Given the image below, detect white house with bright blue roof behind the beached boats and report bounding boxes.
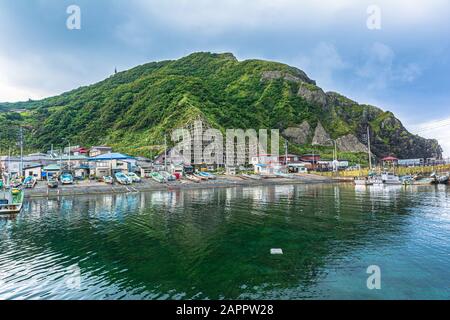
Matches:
[89,153,136,177]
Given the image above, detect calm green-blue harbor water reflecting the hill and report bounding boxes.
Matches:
[0,185,450,299]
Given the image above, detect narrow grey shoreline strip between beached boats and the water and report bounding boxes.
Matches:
[25,174,338,199]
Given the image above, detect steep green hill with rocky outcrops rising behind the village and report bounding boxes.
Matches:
[0,53,442,162]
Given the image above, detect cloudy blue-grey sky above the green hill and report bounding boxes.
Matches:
[0,0,450,156]
